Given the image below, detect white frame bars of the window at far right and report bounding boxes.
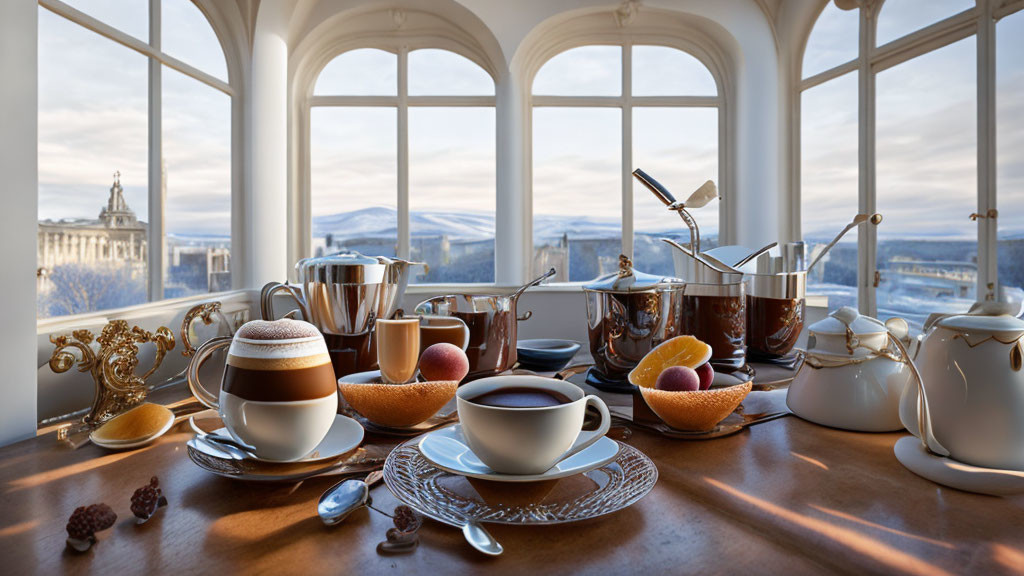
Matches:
[793,0,1024,316]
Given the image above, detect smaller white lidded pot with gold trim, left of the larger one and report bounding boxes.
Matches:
[786,306,912,431]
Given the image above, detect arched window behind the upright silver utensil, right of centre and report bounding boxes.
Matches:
[531,42,723,282]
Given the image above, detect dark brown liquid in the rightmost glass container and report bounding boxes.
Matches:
[746,295,804,360]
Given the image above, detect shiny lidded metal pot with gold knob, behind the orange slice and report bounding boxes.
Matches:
[583,255,684,388]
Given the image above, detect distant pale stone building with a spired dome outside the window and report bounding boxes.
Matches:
[36,172,148,292]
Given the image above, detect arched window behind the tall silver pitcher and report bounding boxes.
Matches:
[309,45,496,283]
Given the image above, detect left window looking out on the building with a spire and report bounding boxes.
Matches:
[37,0,233,318]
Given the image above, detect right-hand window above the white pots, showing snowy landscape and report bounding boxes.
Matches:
[801,0,1024,326]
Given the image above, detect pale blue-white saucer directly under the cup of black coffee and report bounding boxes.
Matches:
[420,424,618,482]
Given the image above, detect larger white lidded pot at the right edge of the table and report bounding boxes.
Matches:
[900,305,1024,470]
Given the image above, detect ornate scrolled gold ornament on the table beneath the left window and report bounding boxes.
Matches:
[49,320,174,427]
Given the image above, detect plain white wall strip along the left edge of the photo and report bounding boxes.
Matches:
[0,0,39,445]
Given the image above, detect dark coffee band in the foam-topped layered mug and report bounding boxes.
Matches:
[221,363,338,402]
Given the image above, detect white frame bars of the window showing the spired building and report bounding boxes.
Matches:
[38,0,244,307]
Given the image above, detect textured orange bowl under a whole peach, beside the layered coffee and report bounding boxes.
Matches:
[338,380,459,427]
